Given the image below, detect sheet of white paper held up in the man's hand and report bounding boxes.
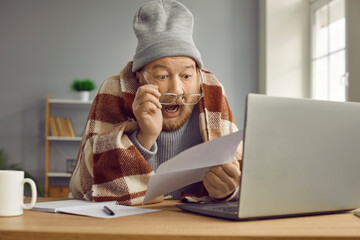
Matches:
[143,131,243,204]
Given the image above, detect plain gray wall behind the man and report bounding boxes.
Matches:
[0,0,258,191]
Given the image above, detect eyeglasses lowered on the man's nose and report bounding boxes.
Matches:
[142,70,204,105]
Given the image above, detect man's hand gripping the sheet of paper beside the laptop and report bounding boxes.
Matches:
[203,160,241,199]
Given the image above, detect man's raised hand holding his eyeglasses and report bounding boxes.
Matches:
[132,84,163,149]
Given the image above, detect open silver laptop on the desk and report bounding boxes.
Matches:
[178,94,360,220]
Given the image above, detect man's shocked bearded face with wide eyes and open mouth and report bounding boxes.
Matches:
[137,57,200,131]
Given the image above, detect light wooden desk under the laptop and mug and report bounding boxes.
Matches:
[0,199,360,240]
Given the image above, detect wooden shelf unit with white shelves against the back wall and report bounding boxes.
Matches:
[45,95,92,197]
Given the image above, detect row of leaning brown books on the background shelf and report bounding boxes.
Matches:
[49,117,75,137]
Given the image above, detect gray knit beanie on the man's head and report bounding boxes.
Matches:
[132,0,203,72]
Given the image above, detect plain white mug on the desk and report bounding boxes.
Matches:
[0,170,37,216]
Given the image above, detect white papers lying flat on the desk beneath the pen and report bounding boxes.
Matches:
[32,200,160,218]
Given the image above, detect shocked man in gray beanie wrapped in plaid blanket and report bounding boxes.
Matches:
[70,0,241,205]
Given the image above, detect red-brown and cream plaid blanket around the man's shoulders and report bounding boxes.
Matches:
[70,62,241,205]
